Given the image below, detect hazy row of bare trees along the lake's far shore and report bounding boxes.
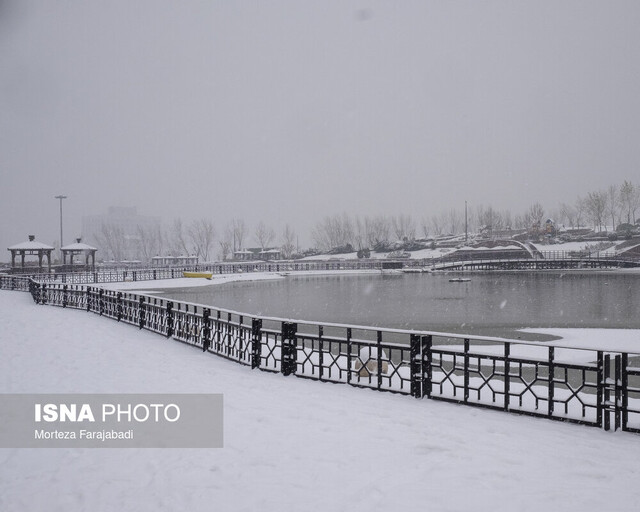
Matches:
[94,181,640,262]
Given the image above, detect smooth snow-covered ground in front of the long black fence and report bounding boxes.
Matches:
[0,291,640,512]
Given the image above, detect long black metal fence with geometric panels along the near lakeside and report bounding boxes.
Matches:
[29,280,640,432]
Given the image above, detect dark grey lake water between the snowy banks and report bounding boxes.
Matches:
[159,272,640,339]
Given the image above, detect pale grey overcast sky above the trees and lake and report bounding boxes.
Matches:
[0,0,640,254]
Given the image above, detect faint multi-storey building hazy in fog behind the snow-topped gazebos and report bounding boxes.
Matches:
[82,206,160,261]
